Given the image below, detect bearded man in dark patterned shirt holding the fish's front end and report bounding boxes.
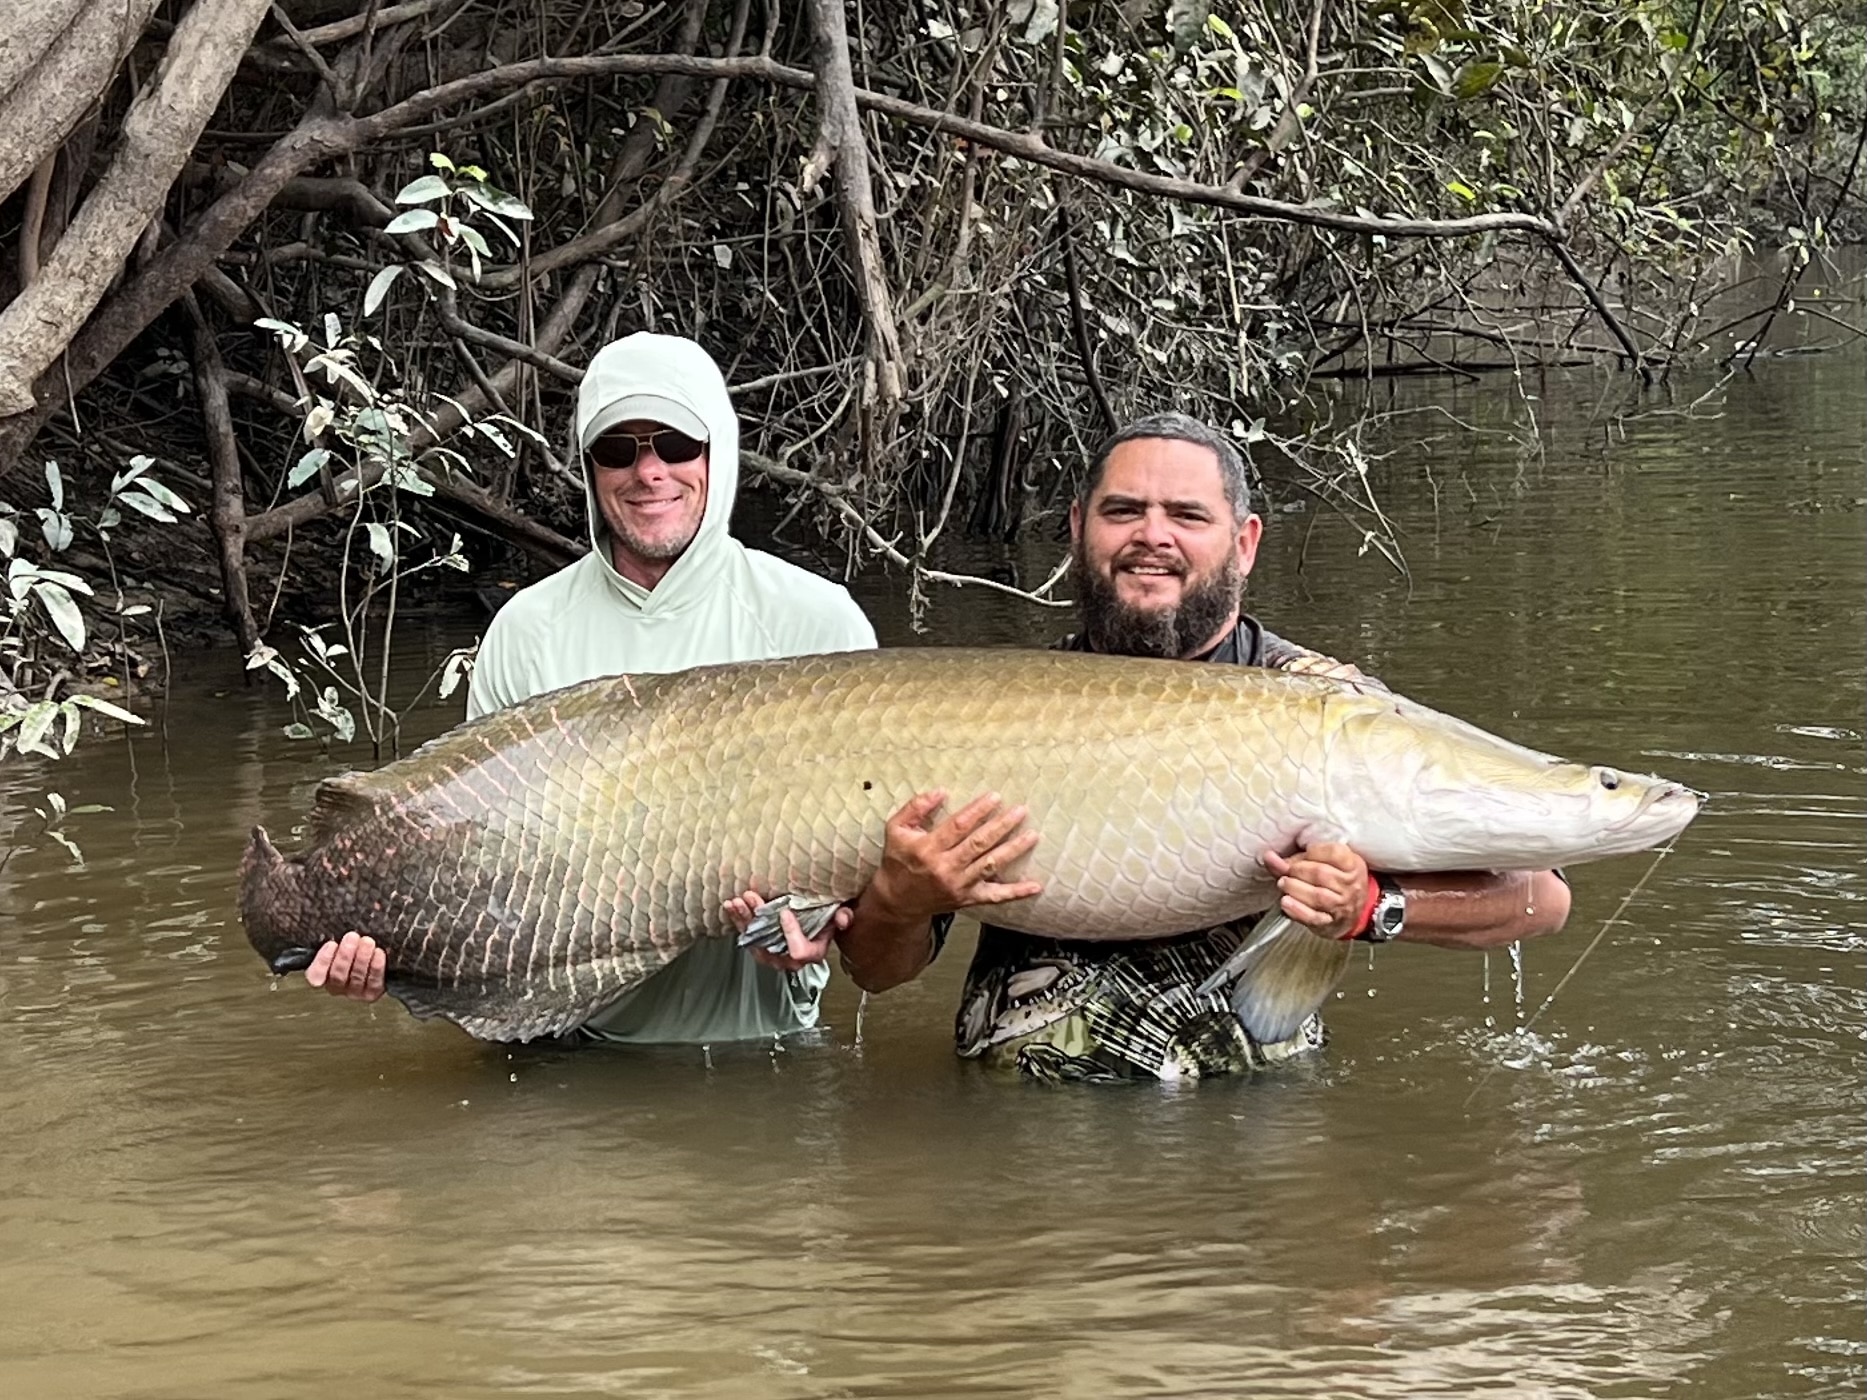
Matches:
[758,413,1568,1081]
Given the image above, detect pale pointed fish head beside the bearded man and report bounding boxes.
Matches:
[1329,698,1703,872]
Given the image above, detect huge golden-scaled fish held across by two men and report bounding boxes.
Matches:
[241,650,1697,1040]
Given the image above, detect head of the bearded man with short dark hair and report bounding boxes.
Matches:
[1070,437,1262,655]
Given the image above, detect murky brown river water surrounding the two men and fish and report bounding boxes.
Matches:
[0,349,1867,1400]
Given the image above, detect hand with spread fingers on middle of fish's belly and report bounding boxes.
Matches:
[863,791,1044,922]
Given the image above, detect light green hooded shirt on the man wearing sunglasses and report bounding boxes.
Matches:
[467,332,876,1043]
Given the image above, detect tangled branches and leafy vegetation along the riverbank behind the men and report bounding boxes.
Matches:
[0,0,1867,757]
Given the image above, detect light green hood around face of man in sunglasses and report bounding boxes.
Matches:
[571,330,739,612]
